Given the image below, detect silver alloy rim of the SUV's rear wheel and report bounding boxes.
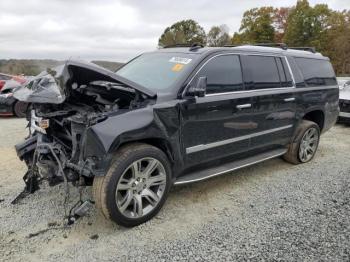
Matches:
[299,127,319,163]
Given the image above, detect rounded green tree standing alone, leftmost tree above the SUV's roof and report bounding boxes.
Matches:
[158,19,206,46]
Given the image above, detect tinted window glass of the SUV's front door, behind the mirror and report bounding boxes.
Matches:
[194,55,243,94]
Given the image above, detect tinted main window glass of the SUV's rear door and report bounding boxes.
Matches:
[246,56,281,89]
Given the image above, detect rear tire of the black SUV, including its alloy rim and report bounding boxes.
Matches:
[283,120,320,165]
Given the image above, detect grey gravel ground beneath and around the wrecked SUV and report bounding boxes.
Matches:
[0,118,350,262]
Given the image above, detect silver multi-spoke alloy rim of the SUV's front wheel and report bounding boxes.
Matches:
[115,158,167,218]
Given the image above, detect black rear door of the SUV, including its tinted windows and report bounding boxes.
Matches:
[242,55,297,149]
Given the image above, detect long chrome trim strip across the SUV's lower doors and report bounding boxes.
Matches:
[186,125,293,154]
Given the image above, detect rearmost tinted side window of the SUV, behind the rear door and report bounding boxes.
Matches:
[295,58,337,86]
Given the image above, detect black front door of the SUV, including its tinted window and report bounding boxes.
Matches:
[182,54,252,166]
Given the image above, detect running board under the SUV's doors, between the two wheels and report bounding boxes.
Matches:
[174,148,287,185]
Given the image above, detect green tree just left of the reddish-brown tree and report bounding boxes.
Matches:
[239,7,275,43]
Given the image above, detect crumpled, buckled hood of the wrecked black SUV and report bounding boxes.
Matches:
[13,60,156,104]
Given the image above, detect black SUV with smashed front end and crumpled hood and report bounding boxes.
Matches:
[14,45,339,227]
